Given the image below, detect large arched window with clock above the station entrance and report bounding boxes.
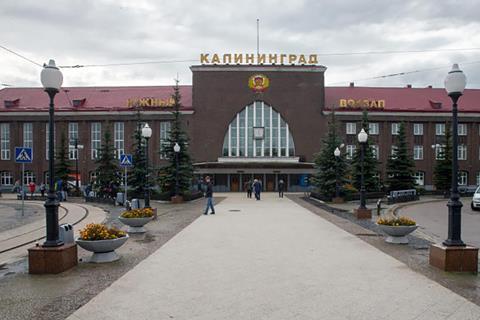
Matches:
[222,101,295,158]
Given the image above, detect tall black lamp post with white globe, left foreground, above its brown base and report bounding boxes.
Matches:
[40,60,63,247]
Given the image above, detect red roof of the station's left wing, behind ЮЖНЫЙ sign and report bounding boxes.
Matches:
[0,86,192,112]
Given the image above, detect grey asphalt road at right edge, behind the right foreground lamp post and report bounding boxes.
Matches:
[399,197,480,248]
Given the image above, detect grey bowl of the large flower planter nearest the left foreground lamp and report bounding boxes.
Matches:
[75,234,128,263]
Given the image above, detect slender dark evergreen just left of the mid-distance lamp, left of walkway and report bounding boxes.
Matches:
[128,111,147,197]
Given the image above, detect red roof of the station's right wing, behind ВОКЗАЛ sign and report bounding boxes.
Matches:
[325,87,480,112]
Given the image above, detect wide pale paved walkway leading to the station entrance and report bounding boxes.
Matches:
[68,194,480,320]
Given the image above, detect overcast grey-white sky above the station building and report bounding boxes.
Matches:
[0,0,480,88]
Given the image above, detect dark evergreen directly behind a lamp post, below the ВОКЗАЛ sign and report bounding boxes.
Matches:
[351,109,382,192]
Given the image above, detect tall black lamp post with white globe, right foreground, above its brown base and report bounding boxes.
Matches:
[443,64,467,247]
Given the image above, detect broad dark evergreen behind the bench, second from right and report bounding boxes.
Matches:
[386,122,415,190]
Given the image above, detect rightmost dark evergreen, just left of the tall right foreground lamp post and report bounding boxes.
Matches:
[433,123,453,193]
